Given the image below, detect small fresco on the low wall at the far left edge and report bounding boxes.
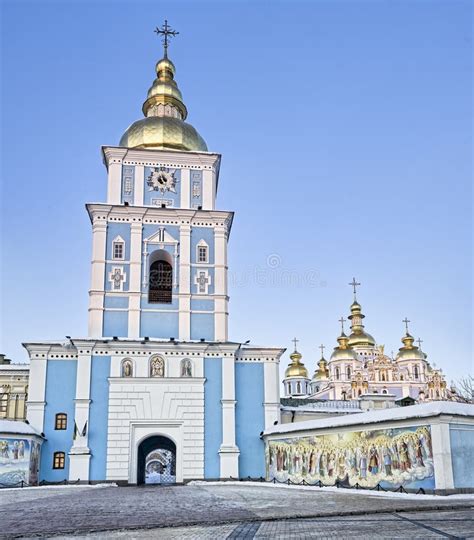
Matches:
[0,438,40,486]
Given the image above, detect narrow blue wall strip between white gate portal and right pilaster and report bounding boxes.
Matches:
[204,358,222,478]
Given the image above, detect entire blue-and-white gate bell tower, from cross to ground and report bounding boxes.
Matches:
[24,23,284,484]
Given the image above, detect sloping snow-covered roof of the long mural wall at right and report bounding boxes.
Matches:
[264,401,474,435]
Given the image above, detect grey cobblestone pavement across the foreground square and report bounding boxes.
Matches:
[0,484,474,539]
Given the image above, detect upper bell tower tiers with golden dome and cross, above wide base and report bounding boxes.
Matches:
[87,22,233,341]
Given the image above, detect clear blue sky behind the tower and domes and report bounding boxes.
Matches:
[1,0,473,380]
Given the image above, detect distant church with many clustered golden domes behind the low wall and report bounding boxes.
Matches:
[283,279,455,402]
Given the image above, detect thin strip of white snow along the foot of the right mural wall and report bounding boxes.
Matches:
[188,480,474,501]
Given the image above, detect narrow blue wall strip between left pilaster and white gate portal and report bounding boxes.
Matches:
[89,356,110,480]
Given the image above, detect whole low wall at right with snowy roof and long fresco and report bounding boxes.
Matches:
[263,402,474,493]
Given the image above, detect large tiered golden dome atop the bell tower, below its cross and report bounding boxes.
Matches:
[119,57,207,152]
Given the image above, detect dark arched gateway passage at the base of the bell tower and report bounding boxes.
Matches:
[137,435,176,484]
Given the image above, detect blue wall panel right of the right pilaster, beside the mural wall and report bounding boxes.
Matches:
[235,362,265,478]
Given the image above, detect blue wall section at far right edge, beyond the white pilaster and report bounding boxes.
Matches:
[449,424,474,488]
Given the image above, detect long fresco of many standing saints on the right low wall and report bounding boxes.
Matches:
[265,426,435,489]
